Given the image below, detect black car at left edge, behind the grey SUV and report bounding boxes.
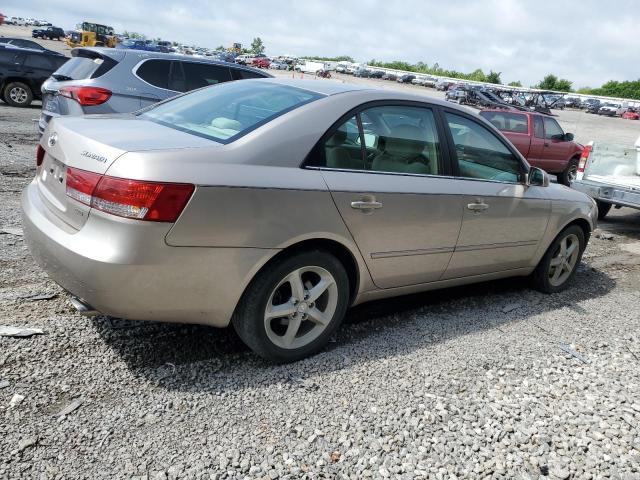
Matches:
[0,44,67,107]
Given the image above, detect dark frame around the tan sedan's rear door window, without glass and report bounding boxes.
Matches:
[300,100,456,179]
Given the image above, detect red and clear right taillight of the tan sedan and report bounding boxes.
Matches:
[67,168,195,222]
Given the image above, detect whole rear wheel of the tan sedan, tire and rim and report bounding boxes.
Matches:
[231,250,349,363]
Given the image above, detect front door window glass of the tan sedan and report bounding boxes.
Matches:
[446,113,522,183]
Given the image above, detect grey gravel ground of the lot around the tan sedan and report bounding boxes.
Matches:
[0,27,640,479]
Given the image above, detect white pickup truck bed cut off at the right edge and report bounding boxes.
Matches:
[571,137,640,219]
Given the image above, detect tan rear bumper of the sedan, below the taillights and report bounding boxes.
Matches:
[22,181,277,327]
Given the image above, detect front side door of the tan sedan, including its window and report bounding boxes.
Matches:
[443,110,551,279]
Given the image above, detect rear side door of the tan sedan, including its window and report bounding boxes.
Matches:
[312,103,462,288]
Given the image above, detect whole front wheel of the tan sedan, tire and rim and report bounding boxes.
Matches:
[531,225,586,293]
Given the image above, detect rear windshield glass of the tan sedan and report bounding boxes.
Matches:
[139,80,323,143]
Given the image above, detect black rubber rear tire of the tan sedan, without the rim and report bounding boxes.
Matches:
[231,250,349,363]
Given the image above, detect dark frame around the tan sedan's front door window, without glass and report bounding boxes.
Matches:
[440,106,531,185]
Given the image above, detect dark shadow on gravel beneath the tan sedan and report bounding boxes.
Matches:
[93,263,615,393]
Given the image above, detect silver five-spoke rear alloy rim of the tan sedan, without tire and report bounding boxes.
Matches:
[264,266,338,349]
